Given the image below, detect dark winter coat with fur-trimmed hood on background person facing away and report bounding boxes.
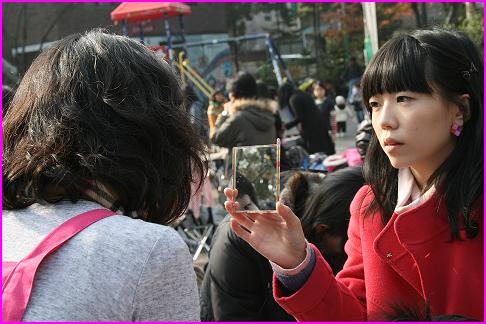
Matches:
[212,99,277,150]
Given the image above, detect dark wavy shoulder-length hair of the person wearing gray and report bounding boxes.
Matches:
[2,30,206,224]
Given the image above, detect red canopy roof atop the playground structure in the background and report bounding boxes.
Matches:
[111,2,192,22]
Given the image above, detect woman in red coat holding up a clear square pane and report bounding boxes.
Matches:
[225,29,484,321]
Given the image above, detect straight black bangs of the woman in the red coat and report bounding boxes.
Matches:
[361,35,433,111]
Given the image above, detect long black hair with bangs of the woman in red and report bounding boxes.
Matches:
[362,29,484,238]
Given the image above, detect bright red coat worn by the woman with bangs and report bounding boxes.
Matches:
[273,186,484,321]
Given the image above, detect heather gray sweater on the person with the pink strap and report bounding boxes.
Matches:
[2,201,199,322]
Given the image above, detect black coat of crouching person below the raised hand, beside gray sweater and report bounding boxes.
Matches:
[200,216,295,322]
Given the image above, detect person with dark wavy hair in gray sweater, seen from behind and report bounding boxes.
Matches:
[2,30,206,321]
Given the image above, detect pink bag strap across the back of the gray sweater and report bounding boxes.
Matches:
[2,209,116,322]
